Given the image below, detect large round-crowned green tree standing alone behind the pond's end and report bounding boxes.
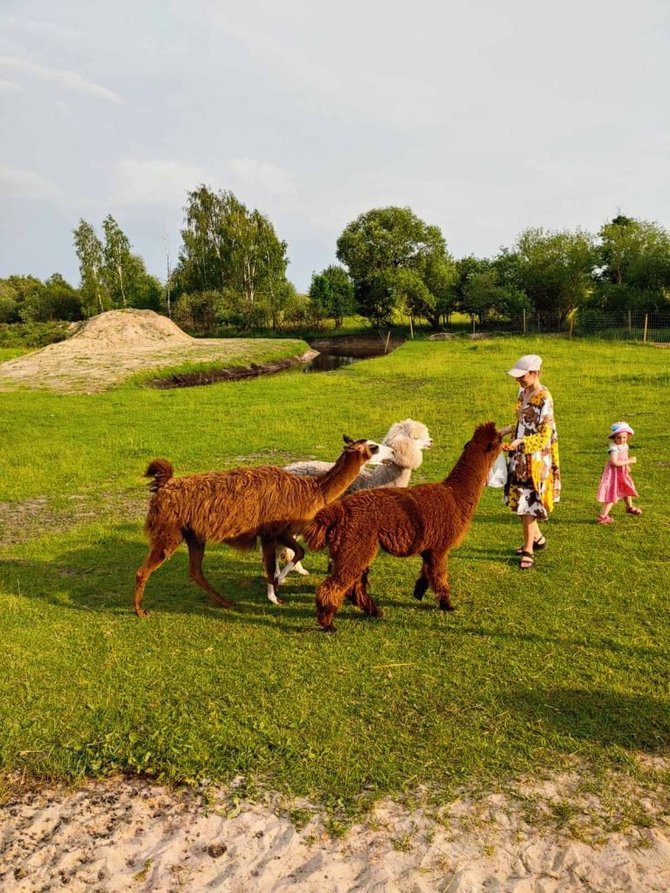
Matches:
[337,207,455,328]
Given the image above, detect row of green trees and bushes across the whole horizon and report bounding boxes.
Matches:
[0,185,670,335]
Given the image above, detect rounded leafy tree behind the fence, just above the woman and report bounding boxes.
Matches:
[515,227,597,319]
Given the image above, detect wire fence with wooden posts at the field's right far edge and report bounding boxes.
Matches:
[472,310,670,342]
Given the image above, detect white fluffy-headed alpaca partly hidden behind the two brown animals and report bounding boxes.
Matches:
[284,419,433,576]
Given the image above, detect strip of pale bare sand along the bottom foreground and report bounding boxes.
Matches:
[0,775,670,893]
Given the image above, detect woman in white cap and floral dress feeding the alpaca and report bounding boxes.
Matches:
[500,354,561,570]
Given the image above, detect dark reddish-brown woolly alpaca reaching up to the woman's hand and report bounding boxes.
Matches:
[303,422,501,631]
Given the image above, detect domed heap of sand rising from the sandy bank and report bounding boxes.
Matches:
[67,310,194,350]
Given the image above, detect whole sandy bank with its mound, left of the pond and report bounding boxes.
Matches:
[0,310,310,394]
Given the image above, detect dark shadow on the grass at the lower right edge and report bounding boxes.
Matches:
[508,688,670,753]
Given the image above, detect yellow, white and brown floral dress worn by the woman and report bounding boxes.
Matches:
[503,387,561,521]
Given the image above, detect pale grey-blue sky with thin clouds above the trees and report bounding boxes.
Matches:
[0,0,670,291]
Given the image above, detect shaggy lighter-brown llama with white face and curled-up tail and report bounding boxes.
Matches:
[135,437,390,617]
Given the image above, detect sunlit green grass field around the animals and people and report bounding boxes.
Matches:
[0,338,670,821]
